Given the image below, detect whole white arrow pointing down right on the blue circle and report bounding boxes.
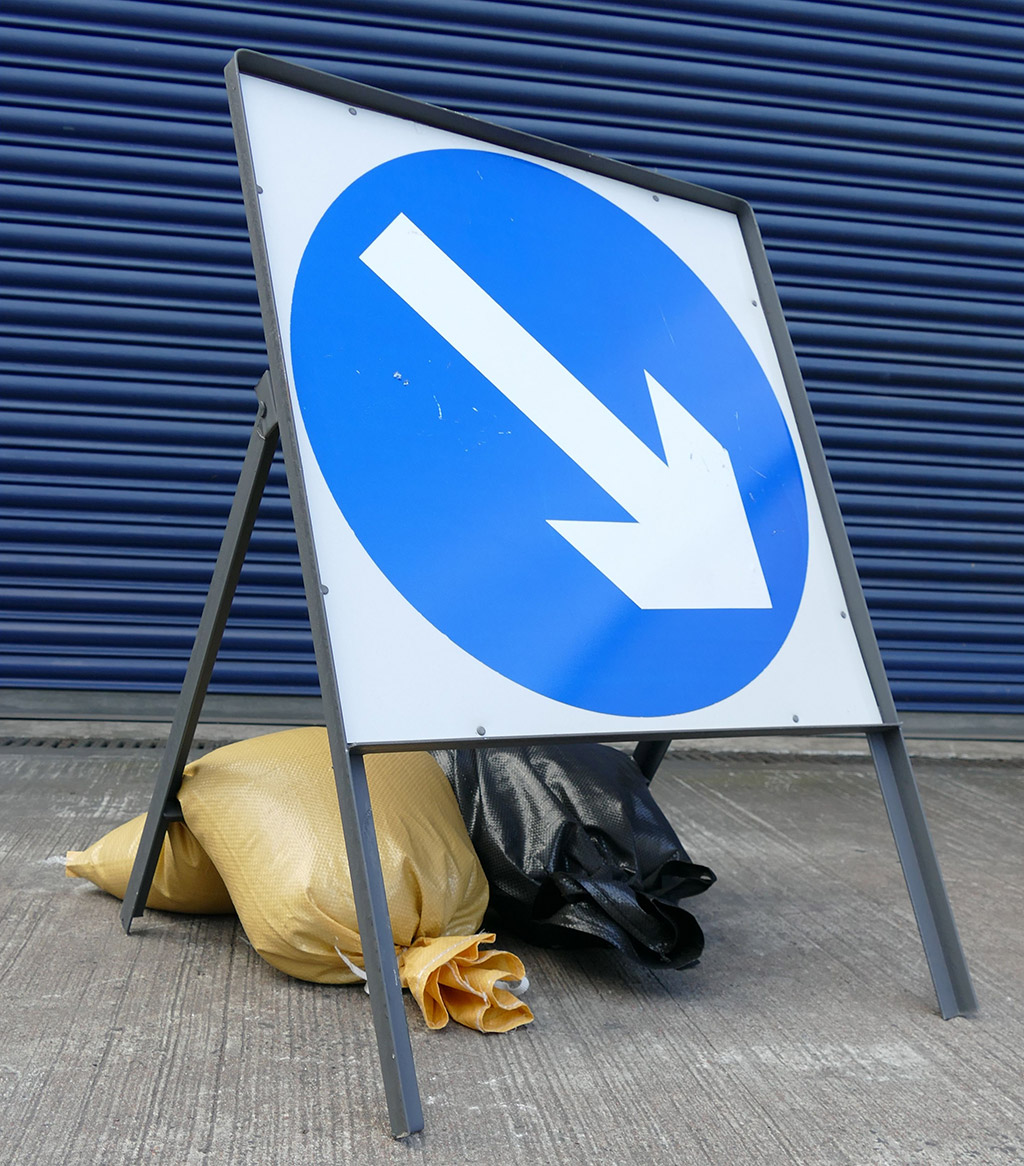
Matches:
[359,215,772,609]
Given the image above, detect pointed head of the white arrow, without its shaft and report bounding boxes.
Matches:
[548,371,772,610]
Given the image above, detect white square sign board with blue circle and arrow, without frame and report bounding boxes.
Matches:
[232,73,882,746]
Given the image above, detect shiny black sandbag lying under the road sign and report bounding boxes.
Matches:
[434,744,715,968]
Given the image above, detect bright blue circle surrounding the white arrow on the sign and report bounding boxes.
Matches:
[290,149,807,717]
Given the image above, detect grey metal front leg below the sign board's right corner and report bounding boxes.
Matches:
[868,726,977,1020]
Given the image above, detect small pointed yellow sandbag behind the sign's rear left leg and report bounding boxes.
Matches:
[64,814,234,915]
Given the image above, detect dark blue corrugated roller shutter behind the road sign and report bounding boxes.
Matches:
[0,0,1024,711]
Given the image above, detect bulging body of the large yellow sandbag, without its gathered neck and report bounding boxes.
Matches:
[178,728,488,984]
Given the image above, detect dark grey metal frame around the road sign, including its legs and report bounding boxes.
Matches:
[121,51,977,1137]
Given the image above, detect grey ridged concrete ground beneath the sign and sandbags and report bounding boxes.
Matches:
[0,710,1024,1166]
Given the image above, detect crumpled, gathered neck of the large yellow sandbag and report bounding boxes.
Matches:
[398,933,533,1032]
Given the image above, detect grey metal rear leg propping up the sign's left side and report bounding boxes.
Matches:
[121,372,278,934]
